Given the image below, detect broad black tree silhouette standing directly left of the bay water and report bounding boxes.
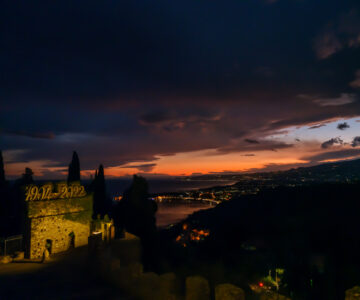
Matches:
[114,175,158,270]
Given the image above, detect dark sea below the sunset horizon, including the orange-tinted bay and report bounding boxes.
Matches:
[106,178,235,228]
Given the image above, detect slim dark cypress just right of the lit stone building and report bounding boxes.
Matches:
[91,165,111,219]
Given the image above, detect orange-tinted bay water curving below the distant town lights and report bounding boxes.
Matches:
[156,203,211,228]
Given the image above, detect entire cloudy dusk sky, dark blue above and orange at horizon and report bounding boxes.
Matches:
[0,0,360,179]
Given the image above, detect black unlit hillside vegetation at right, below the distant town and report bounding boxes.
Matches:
[161,183,360,300]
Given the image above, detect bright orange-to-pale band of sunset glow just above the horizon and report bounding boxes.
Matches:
[5,119,360,177]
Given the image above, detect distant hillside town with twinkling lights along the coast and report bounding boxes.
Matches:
[148,160,360,205]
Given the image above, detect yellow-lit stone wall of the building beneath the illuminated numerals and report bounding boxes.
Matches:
[25,195,93,259]
